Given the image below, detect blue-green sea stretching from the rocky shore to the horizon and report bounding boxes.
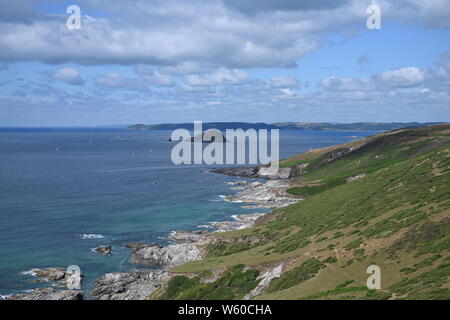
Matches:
[0,128,373,294]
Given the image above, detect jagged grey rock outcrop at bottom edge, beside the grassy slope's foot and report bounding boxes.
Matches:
[90,270,168,300]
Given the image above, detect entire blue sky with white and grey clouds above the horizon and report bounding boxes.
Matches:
[0,0,450,127]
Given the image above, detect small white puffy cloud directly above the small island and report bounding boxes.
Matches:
[183,68,251,87]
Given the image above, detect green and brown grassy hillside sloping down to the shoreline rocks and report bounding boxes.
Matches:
[156,124,450,299]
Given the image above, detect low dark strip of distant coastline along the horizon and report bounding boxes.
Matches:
[126,122,442,131]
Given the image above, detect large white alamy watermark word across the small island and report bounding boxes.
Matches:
[171,121,280,174]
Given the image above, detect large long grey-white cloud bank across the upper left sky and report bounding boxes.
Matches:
[0,3,318,68]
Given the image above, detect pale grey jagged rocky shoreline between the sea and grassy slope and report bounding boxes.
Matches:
[3,168,300,300]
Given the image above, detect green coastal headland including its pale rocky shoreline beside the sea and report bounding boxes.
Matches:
[8,124,450,299]
